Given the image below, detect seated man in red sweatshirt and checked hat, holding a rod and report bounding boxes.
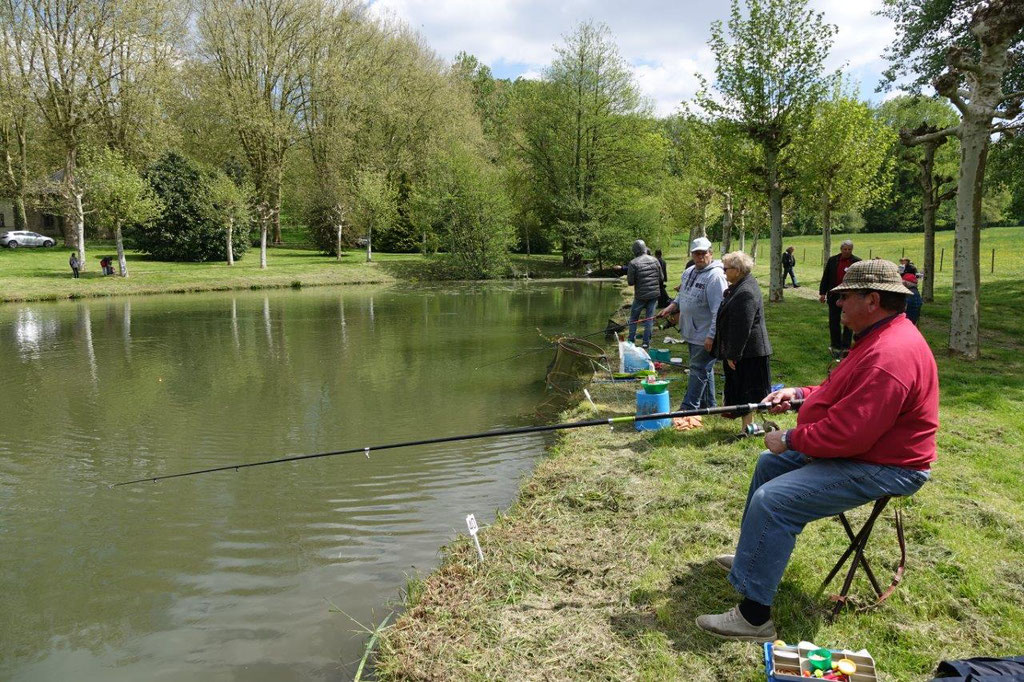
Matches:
[696,260,939,641]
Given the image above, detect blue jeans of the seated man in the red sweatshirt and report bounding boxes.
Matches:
[729,450,931,604]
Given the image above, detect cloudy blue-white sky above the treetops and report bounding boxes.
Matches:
[371,0,895,116]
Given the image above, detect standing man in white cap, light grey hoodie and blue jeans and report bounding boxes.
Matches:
[658,237,729,429]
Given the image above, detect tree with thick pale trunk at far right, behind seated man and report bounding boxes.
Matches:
[883,0,1024,358]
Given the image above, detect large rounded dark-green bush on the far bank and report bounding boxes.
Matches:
[138,152,249,262]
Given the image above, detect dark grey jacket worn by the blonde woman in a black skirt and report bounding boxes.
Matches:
[712,274,771,360]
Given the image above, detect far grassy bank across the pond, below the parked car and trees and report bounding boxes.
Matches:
[0,244,565,301]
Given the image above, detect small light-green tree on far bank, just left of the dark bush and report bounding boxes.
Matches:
[81,148,163,278]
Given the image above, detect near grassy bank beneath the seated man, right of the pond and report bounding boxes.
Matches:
[377,228,1024,682]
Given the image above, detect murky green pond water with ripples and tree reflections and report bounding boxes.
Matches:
[0,282,621,681]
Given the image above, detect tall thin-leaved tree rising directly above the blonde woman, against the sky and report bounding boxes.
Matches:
[697,0,836,301]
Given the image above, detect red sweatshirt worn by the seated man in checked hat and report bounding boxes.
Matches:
[788,314,939,469]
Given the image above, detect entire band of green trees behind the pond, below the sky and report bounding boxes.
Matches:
[0,0,1024,356]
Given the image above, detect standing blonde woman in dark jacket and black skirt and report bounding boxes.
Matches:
[712,251,771,430]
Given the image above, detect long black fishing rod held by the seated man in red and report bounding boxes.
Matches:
[111,400,803,487]
